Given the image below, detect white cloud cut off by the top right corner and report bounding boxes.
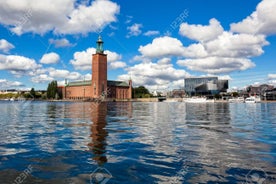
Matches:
[231,0,276,35]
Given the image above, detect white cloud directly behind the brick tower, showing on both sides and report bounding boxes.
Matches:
[70,48,126,70]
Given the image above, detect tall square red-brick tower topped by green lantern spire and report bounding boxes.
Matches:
[91,36,107,98]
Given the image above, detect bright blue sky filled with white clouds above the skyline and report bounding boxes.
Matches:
[0,0,276,91]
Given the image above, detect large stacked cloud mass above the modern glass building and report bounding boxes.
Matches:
[177,19,269,74]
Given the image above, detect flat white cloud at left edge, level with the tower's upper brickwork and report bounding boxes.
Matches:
[0,54,41,72]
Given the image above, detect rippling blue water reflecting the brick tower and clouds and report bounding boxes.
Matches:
[0,101,276,184]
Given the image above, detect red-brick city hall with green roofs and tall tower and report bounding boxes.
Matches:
[59,36,132,100]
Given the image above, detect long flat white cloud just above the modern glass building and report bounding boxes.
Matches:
[177,57,255,74]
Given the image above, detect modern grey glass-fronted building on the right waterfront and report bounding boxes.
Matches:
[184,77,228,96]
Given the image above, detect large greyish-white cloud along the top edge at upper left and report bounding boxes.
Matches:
[0,0,120,35]
